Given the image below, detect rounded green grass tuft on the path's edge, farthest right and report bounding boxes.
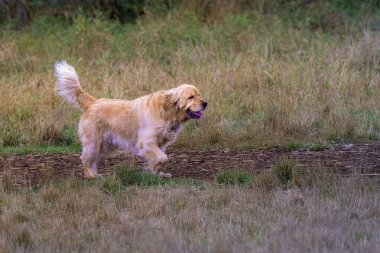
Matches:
[272,159,306,187]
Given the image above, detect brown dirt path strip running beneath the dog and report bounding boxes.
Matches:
[0,142,380,186]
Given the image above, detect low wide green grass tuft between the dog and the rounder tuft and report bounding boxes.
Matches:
[215,170,252,185]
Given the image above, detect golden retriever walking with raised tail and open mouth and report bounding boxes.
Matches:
[55,61,207,178]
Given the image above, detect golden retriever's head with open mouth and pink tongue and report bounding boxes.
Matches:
[164,84,207,120]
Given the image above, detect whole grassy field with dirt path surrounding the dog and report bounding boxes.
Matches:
[0,0,380,252]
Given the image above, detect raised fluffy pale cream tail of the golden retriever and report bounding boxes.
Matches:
[55,61,96,111]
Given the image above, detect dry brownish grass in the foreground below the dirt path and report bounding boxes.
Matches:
[0,172,380,252]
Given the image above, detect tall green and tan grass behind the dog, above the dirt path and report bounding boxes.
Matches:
[0,1,380,147]
